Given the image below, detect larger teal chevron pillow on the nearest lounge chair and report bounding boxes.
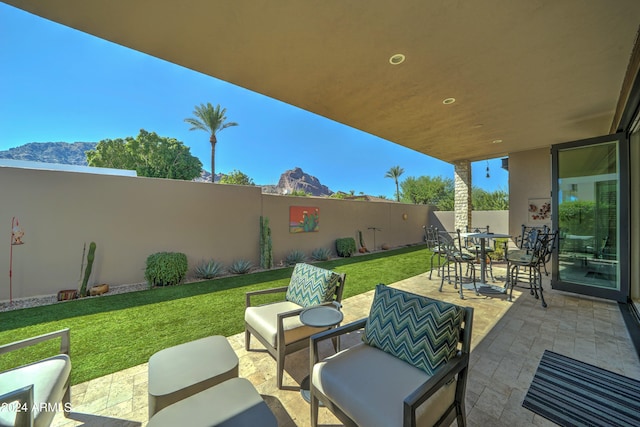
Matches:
[362,284,464,375]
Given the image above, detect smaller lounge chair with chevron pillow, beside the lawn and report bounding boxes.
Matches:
[244,263,345,389]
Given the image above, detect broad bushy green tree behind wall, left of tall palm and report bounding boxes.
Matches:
[86,129,202,181]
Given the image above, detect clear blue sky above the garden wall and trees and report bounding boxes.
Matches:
[0,3,508,197]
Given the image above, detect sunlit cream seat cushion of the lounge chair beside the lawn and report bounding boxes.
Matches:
[244,301,327,347]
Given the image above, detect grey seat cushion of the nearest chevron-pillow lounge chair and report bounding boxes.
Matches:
[312,343,456,427]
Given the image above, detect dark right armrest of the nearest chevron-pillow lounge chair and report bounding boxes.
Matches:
[403,353,469,426]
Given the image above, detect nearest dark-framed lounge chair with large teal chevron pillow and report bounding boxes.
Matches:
[310,285,473,427]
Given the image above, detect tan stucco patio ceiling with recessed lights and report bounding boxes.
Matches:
[6,0,640,162]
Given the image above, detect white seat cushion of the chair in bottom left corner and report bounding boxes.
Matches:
[0,354,71,427]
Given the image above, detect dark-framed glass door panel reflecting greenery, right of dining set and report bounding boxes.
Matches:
[551,134,629,301]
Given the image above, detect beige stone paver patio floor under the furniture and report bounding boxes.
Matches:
[53,267,640,427]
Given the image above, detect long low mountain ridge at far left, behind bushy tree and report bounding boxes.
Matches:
[0,142,98,166]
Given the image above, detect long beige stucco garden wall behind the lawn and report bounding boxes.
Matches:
[0,167,430,300]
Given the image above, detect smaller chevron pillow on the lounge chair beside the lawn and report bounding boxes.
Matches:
[285,263,339,307]
